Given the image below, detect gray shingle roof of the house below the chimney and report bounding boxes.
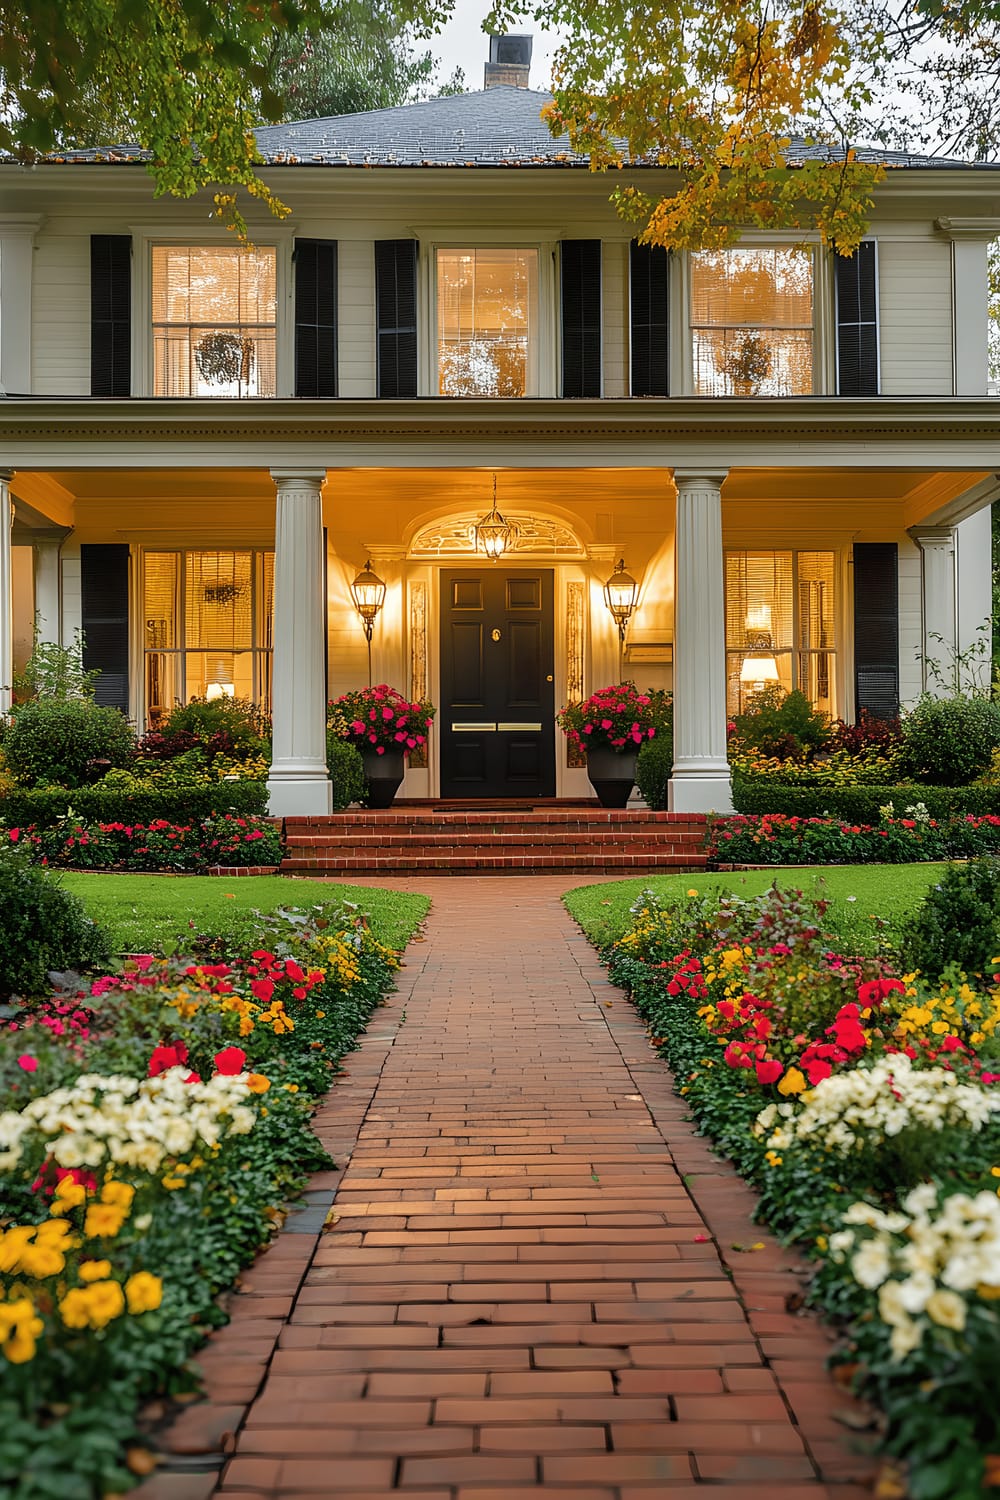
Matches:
[27,84,1000,168]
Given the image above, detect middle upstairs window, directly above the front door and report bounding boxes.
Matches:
[438,249,538,396]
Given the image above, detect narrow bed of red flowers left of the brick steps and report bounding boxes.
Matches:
[6,813,282,873]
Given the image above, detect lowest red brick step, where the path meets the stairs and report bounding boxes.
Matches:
[282,849,706,875]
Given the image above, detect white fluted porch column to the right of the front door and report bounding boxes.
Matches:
[670,470,733,813]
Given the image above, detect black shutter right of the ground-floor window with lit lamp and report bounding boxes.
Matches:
[855,542,900,719]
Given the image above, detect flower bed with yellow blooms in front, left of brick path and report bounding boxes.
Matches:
[0,912,397,1500]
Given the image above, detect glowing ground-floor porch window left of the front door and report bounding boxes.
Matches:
[141,551,274,728]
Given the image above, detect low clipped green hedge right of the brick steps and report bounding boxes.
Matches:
[733,776,1000,824]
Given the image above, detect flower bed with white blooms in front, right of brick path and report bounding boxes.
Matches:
[607,891,1000,1500]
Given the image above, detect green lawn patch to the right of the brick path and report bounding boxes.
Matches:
[564,864,948,953]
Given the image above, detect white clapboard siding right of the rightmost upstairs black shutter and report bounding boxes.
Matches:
[879,239,954,396]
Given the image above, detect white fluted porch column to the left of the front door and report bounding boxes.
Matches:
[267,470,331,818]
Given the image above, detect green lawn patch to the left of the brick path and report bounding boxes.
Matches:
[60,873,430,953]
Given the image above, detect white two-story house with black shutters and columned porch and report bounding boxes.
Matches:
[0,38,1000,813]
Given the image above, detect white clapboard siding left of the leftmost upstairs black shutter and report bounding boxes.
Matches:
[31,230,90,396]
